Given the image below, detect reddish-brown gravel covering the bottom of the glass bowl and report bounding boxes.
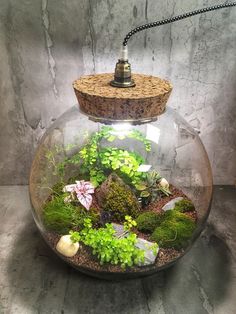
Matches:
[43,186,197,280]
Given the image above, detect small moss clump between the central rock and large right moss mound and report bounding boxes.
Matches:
[136,211,163,233]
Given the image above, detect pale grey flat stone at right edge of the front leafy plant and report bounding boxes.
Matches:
[135,238,159,266]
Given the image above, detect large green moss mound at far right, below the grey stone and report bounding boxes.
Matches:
[151,210,195,249]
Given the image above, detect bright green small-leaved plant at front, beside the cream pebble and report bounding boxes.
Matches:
[72,219,144,268]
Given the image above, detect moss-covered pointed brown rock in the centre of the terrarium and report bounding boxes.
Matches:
[103,182,139,222]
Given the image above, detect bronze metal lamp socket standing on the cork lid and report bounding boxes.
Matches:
[110,59,135,88]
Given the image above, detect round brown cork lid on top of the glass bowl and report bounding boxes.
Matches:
[73,73,172,120]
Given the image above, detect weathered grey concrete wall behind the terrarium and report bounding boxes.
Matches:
[0,0,236,184]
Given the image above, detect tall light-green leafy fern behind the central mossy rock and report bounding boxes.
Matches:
[51,126,151,187]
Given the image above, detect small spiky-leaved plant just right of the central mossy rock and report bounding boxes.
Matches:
[135,170,171,205]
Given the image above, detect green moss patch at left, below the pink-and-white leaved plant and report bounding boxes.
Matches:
[43,194,99,234]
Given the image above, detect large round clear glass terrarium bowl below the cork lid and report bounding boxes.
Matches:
[30,106,212,279]
